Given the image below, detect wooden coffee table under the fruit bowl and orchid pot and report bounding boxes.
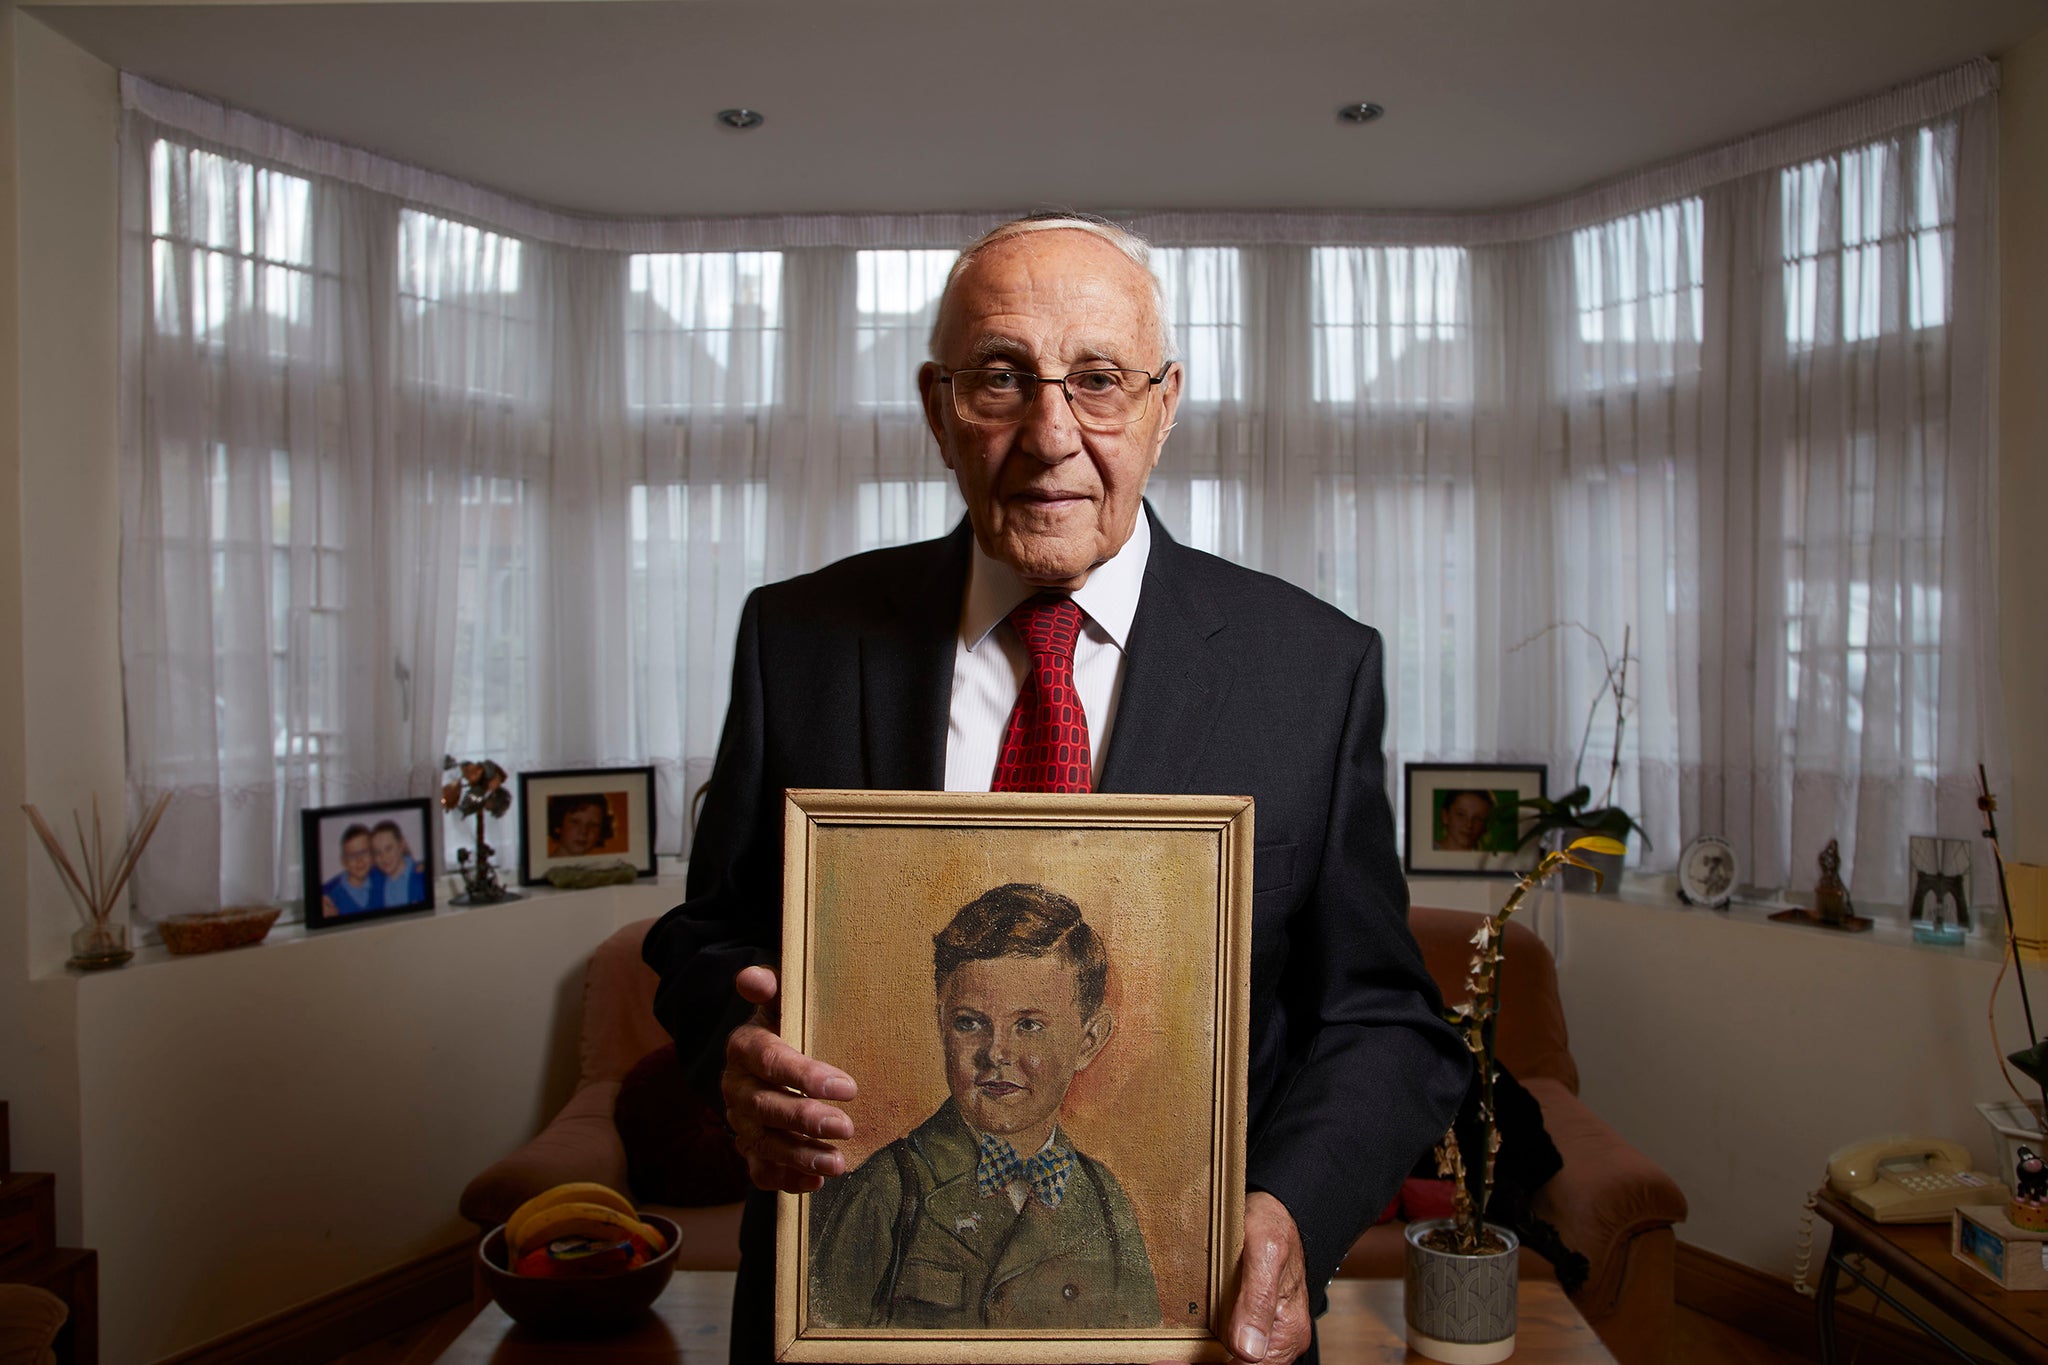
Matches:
[440,1271,1614,1365]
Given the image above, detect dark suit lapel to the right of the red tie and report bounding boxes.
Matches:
[1100,517,1231,794]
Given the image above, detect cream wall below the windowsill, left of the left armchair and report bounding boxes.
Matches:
[78,880,682,1365]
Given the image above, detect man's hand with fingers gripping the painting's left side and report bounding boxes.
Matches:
[719,966,860,1186]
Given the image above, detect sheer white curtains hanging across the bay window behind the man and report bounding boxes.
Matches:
[123,63,2001,913]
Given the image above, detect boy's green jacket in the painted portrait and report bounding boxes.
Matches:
[809,1099,1159,1330]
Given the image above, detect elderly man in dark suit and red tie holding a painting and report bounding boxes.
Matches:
[645,217,1470,1365]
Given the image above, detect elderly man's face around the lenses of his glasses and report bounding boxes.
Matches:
[918,229,1180,589]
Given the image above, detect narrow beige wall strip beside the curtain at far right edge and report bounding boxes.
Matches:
[1997,29,2048,862]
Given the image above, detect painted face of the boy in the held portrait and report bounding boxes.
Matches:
[938,956,1110,1156]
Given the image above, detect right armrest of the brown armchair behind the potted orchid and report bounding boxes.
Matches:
[1524,1076,1686,1318]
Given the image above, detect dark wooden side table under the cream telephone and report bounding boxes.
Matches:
[1812,1189,2048,1365]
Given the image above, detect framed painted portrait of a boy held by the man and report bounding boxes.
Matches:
[776,790,1251,1363]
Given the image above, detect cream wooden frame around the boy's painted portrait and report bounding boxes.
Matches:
[774,790,1253,1365]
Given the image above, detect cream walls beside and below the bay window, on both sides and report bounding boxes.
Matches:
[12,0,2048,1365]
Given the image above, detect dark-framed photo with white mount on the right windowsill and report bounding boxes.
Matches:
[1403,763,1550,876]
